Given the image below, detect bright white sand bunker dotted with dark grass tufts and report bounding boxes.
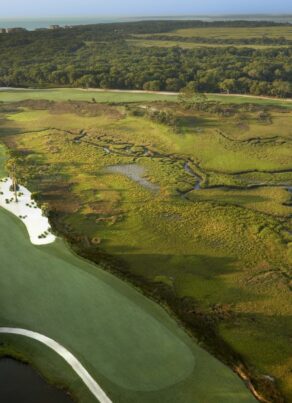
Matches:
[0,178,56,245]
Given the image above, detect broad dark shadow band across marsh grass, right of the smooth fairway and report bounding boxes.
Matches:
[89,245,270,305]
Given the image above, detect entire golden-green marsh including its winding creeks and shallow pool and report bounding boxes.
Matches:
[0,97,292,402]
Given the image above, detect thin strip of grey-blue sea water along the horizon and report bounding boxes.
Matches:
[0,14,292,30]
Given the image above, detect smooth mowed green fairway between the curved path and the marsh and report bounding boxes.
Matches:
[0,144,255,403]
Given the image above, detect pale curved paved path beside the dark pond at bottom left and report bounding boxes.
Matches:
[0,327,112,403]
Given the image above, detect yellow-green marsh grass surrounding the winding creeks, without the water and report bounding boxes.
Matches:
[1,105,292,401]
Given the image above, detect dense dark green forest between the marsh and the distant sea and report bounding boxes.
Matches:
[0,21,292,97]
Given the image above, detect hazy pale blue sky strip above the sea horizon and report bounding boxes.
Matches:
[0,0,292,18]
